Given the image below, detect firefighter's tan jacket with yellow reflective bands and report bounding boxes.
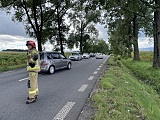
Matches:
[27,48,40,72]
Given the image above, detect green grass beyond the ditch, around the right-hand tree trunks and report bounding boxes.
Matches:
[122,59,160,93]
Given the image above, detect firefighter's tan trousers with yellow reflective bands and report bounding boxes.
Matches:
[28,72,38,98]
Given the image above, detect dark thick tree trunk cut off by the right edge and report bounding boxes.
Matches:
[152,0,160,68]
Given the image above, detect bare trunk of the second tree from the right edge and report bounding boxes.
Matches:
[133,14,140,60]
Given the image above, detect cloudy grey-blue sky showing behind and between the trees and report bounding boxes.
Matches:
[0,11,153,51]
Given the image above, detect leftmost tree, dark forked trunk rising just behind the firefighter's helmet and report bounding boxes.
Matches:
[0,0,58,51]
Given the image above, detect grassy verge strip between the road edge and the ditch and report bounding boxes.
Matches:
[91,57,160,120]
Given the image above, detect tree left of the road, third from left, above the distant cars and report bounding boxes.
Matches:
[69,0,101,53]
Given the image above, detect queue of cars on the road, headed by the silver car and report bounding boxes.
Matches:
[40,51,103,74]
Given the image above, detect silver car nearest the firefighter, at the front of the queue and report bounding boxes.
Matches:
[40,51,72,74]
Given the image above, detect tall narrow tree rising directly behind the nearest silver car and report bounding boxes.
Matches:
[50,0,74,54]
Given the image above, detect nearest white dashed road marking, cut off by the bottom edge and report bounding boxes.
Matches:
[53,102,75,120]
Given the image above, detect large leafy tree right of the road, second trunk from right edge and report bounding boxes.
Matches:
[99,0,151,60]
